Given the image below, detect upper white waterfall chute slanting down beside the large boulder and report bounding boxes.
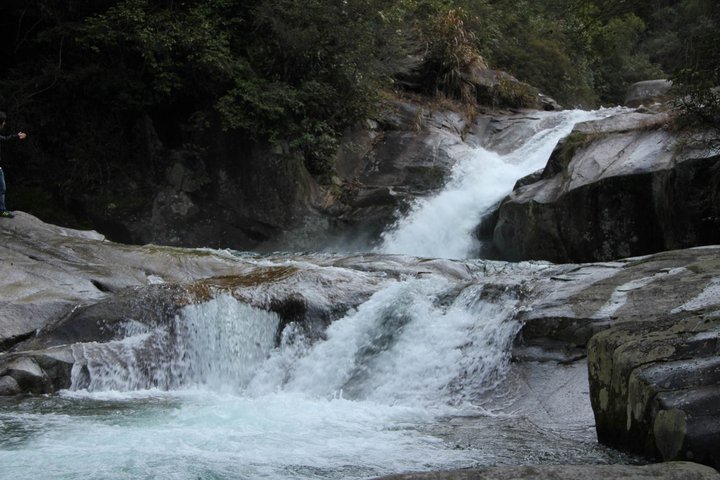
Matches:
[377,110,612,259]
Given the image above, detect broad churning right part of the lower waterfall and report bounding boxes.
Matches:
[252,278,519,406]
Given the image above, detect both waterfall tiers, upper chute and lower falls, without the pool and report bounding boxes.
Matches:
[66,111,609,405]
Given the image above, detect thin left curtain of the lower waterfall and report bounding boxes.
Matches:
[72,295,279,392]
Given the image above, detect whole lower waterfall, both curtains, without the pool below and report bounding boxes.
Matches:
[73,276,519,406]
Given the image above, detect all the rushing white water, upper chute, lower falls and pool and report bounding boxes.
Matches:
[0,112,640,480]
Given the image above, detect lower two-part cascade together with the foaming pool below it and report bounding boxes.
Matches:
[0,275,540,479]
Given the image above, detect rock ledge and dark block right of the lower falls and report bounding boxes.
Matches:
[515,247,720,468]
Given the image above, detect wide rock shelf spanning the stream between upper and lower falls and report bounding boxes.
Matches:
[0,212,720,478]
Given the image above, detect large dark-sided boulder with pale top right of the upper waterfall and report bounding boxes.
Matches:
[493,112,720,262]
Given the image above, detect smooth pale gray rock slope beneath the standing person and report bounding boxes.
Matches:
[0,212,268,349]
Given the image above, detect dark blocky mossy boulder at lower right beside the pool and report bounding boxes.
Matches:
[588,248,720,468]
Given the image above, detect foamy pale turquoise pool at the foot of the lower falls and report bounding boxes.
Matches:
[0,390,467,479]
